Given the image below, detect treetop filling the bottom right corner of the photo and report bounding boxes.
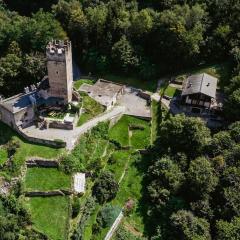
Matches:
[216,217,240,240]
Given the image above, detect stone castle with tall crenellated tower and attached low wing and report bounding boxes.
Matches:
[0,41,73,130]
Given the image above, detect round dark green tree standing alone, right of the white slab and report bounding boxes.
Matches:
[92,171,119,204]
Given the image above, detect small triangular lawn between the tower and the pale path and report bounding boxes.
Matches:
[78,95,105,126]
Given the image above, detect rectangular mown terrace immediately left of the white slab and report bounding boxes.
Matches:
[24,168,71,191]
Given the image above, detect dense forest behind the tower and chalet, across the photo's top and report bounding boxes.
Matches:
[0,0,240,119]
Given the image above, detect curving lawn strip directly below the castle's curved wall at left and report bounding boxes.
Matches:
[0,122,64,176]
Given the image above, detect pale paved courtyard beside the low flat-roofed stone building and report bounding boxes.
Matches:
[118,87,151,118]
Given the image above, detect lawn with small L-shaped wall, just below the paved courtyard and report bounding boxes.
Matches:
[109,115,150,149]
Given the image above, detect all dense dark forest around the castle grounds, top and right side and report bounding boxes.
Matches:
[0,0,240,240]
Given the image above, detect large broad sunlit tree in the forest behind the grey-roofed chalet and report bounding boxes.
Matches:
[152,4,207,70]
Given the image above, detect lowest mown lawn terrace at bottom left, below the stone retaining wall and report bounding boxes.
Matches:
[28,196,70,240]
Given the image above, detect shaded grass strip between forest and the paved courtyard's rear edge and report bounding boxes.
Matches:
[104,74,157,92]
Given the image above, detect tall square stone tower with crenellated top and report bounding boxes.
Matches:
[46,40,73,103]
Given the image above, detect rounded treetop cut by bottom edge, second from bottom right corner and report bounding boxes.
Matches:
[171,210,211,240]
